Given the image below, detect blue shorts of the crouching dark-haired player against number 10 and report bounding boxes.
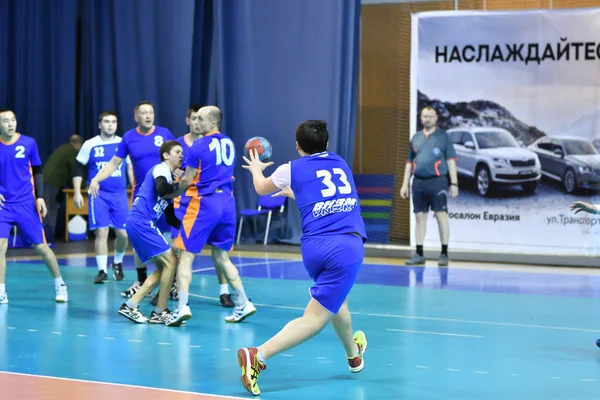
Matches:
[125,218,171,264]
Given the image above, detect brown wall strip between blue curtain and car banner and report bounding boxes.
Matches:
[353,0,600,245]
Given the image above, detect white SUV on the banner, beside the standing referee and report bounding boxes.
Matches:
[448,127,542,196]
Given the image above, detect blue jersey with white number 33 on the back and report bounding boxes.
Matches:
[290,152,367,241]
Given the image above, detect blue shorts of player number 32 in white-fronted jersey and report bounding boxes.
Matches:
[88,191,129,230]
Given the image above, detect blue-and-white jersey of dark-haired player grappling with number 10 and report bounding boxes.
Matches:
[130,163,173,224]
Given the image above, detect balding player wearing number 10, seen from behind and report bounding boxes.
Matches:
[166,106,256,326]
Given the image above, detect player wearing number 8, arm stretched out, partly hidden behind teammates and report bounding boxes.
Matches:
[89,101,175,297]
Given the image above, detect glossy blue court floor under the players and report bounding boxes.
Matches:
[0,253,600,400]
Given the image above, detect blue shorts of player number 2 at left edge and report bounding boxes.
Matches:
[0,200,46,244]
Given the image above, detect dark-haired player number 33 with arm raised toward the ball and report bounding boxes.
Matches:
[238,120,367,395]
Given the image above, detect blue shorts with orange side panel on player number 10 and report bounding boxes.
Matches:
[175,193,236,254]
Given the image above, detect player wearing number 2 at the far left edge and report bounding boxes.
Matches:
[0,109,69,304]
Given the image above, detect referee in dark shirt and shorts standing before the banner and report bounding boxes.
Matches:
[400,106,458,266]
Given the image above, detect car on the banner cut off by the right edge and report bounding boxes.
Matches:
[529,136,600,193]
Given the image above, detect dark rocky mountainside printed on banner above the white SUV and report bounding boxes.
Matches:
[417,92,546,145]
